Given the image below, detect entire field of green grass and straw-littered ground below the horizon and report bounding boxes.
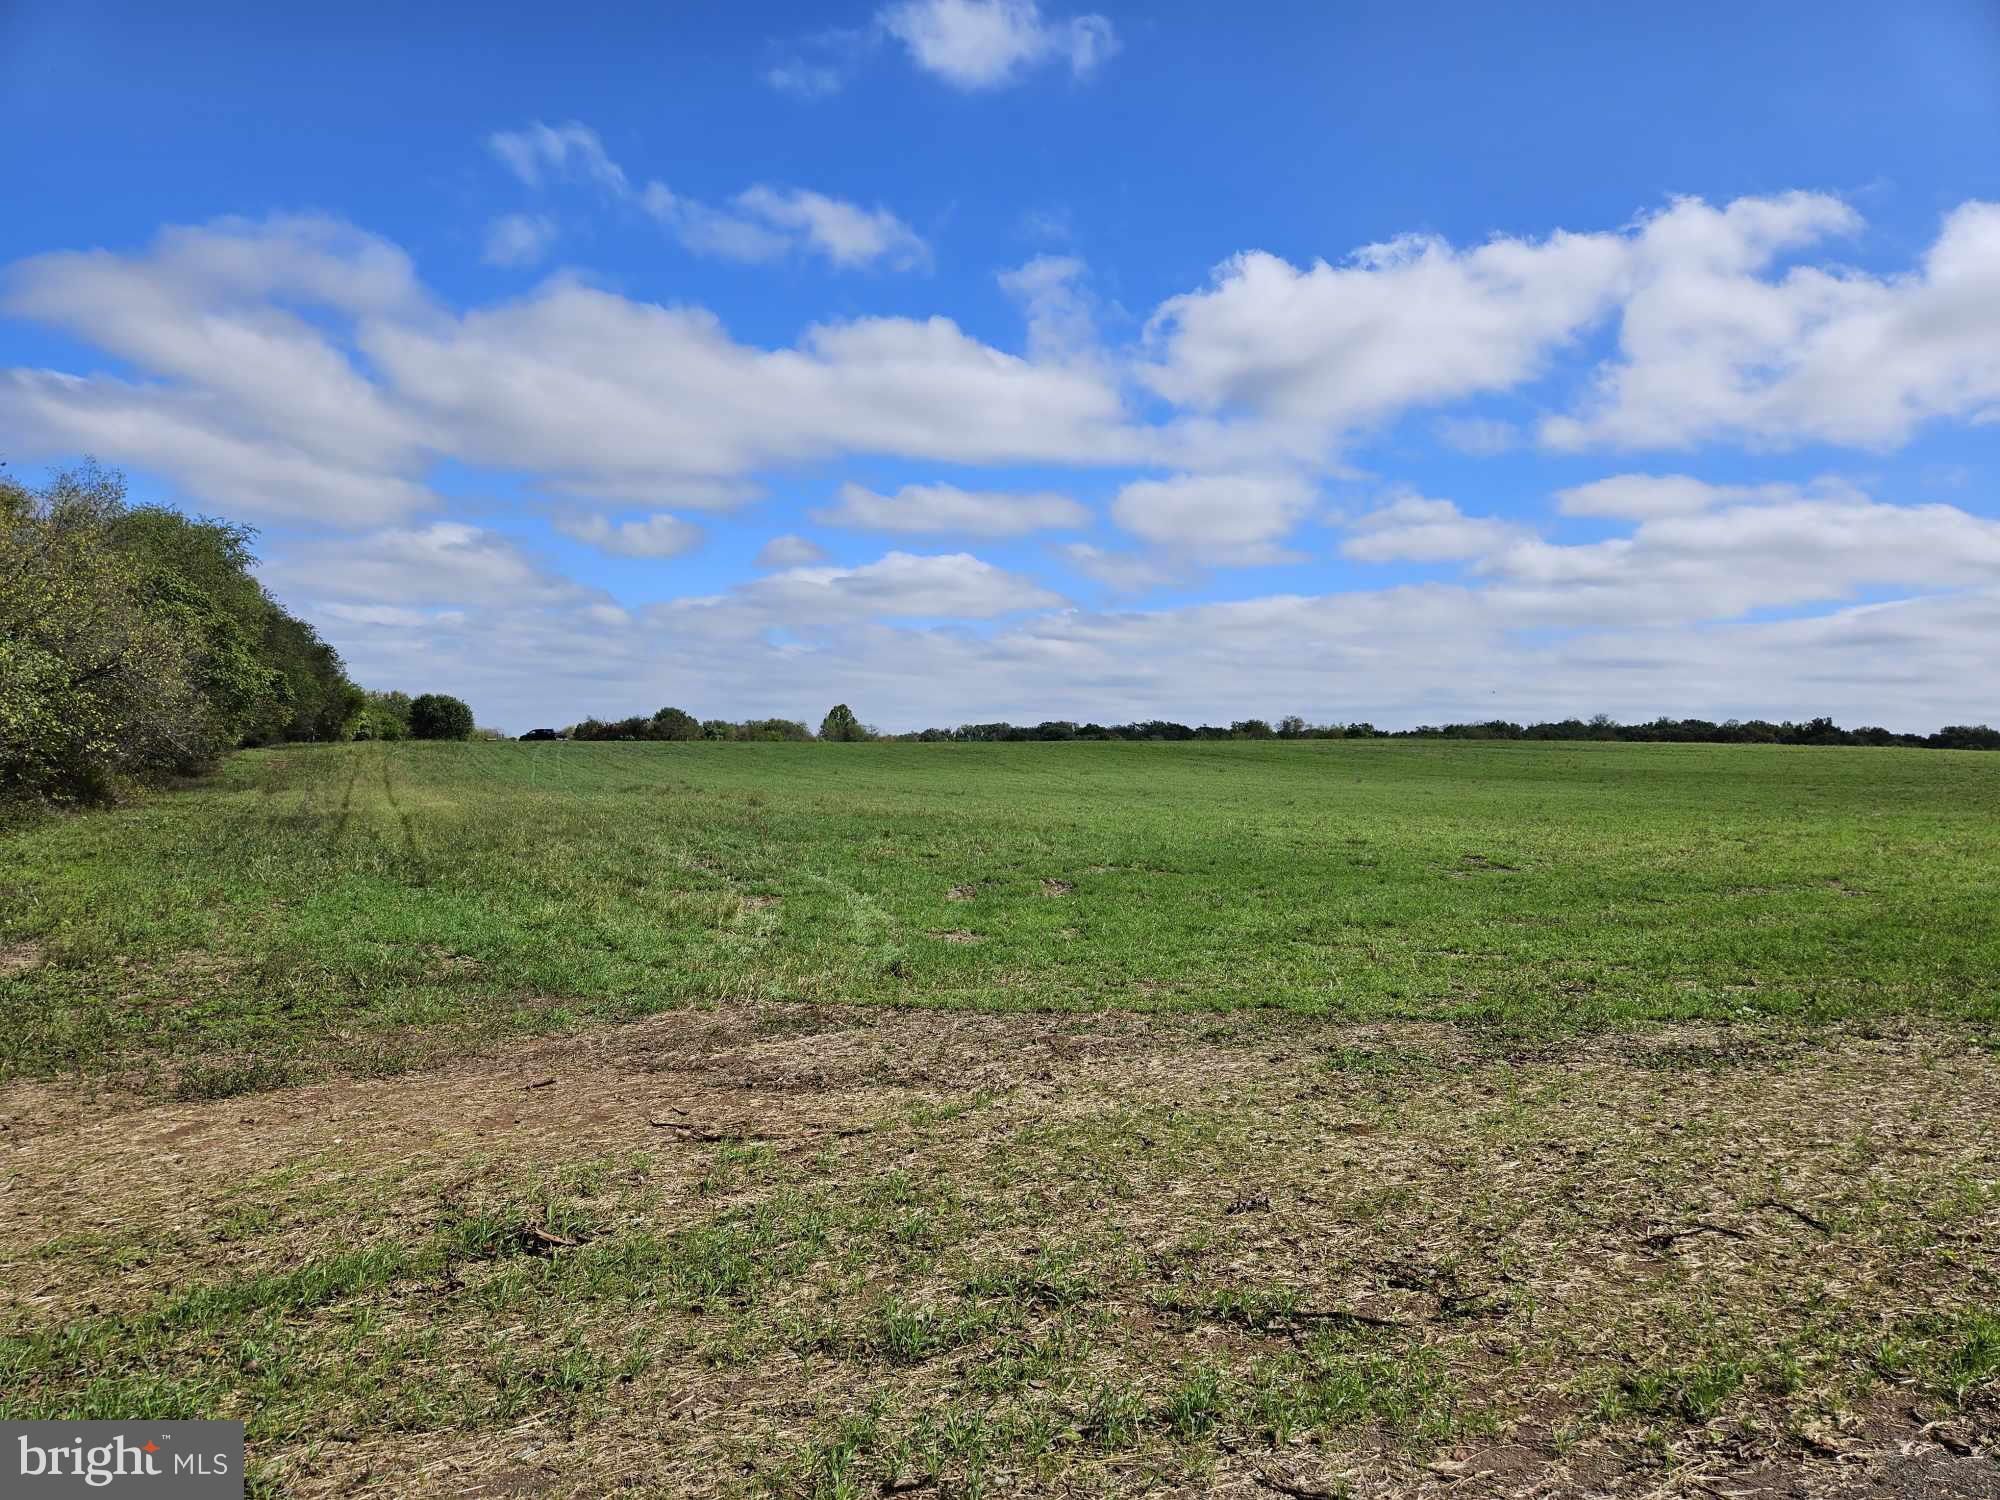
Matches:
[0,742,2000,1500]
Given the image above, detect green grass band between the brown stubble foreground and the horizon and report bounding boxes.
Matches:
[0,742,2000,1096]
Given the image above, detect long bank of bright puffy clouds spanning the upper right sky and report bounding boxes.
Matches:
[1138,192,2000,464]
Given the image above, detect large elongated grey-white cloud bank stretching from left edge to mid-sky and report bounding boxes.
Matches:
[0,220,1142,526]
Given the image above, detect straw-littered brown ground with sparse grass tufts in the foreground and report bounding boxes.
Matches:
[0,1004,2000,1496]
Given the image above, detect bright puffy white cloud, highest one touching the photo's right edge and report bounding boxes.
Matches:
[1542,194,2000,448]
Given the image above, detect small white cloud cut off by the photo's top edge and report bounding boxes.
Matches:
[876,0,1118,90]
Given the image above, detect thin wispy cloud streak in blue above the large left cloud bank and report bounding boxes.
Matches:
[488,120,930,270]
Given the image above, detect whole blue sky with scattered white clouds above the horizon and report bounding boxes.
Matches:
[0,0,2000,730]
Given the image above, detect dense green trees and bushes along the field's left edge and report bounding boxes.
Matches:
[0,462,474,806]
